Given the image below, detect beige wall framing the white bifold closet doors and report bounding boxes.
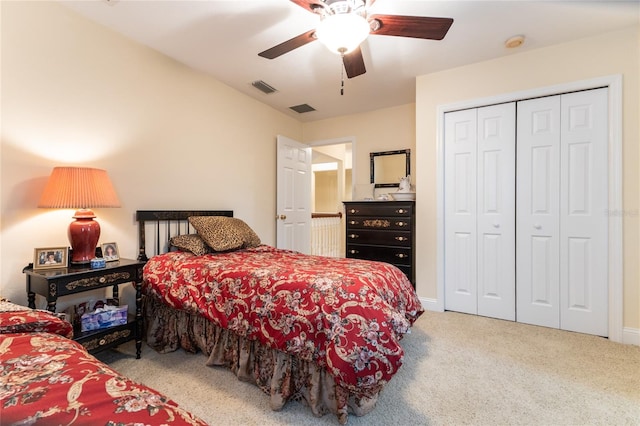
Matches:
[416,27,640,330]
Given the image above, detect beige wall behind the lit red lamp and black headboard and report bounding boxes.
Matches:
[0,2,303,303]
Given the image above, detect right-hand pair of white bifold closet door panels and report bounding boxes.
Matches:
[516,89,608,336]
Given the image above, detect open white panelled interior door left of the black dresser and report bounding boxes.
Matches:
[276,135,312,254]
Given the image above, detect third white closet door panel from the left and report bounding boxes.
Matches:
[516,96,561,328]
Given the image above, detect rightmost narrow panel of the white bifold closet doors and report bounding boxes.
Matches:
[560,88,608,336]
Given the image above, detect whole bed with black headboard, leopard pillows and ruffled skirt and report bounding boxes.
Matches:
[137,210,423,424]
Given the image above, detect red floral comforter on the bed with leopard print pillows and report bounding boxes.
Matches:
[143,245,423,395]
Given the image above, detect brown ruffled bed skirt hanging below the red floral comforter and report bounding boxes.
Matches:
[143,297,379,424]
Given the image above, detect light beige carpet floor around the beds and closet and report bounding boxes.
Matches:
[99,312,640,426]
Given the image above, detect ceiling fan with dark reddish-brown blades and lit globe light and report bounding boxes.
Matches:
[258,0,453,78]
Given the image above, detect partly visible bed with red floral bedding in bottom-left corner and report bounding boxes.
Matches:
[0,300,206,426]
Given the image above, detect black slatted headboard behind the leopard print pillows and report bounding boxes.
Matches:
[136,210,233,262]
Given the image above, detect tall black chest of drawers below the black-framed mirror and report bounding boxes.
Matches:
[344,201,416,287]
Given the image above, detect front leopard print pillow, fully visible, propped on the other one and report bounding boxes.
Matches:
[189,216,260,251]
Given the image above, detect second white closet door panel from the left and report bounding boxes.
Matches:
[477,103,516,321]
